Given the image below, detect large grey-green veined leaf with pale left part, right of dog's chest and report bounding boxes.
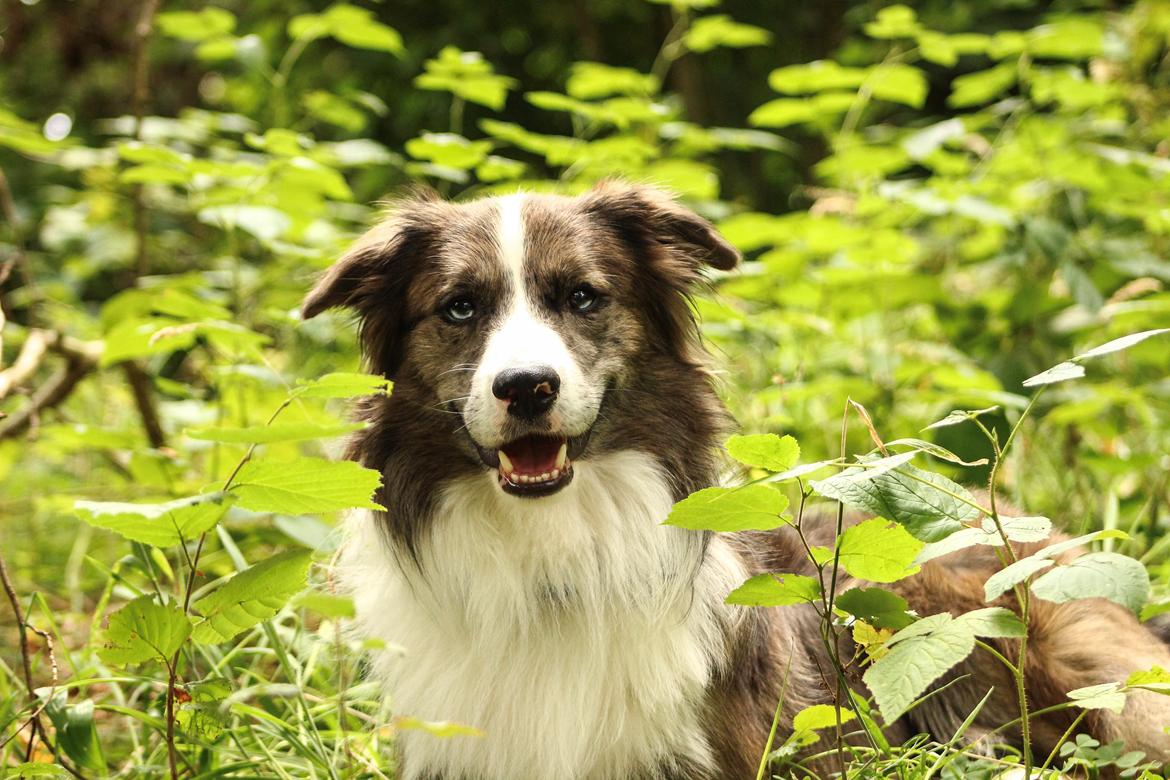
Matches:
[810,465,980,541]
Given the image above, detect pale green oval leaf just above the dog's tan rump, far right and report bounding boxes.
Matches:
[1032,552,1150,613]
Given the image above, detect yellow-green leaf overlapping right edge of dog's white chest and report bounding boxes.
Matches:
[665,484,789,531]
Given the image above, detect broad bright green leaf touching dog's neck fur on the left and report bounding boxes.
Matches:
[230,457,384,515]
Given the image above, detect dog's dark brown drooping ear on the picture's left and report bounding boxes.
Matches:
[301,198,440,379]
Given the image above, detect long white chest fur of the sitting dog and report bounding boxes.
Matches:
[340,453,743,780]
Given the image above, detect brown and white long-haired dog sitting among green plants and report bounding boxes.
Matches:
[302,181,1170,780]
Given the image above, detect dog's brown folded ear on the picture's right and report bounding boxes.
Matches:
[583,181,741,271]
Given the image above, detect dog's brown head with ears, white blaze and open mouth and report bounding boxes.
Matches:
[303,185,738,497]
